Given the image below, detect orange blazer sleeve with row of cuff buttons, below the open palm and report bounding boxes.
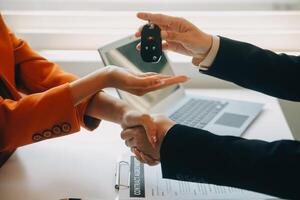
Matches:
[0,83,80,152]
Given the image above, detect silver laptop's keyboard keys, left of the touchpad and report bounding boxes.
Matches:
[170,99,228,128]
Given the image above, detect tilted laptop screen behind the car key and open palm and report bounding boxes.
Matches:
[100,39,180,110]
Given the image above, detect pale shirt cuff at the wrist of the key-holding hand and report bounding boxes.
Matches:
[196,35,220,70]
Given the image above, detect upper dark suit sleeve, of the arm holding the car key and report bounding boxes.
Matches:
[203,37,300,101]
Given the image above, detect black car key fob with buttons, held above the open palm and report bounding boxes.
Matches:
[141,24,162,63]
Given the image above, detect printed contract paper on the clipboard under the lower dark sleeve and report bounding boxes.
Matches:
[118,156,276,200]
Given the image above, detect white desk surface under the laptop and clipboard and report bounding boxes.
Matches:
[0,89,293,200]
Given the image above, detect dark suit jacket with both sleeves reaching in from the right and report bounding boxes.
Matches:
[161,37,300,199]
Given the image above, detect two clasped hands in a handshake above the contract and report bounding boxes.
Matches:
[121,110,175,165]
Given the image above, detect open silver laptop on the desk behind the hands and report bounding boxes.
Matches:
[98,36,263,136]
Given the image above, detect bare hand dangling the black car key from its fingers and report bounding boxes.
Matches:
[135,12,213,66]
